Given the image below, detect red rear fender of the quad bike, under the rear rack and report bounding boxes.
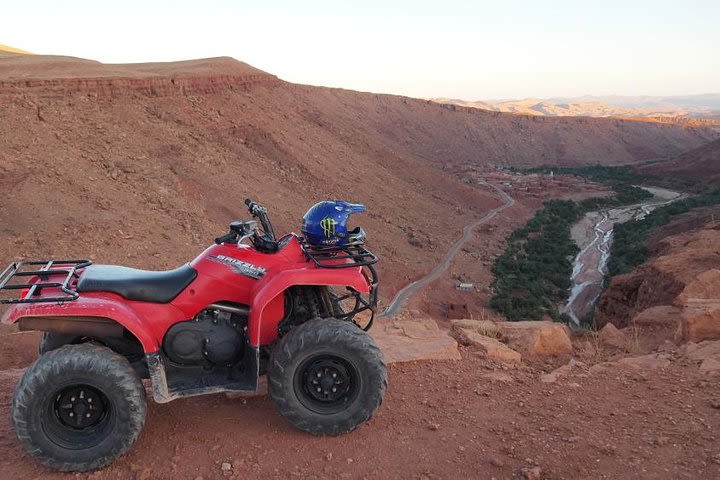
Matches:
[2,292,185,353]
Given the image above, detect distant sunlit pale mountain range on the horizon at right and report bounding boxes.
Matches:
[432,93,720,119]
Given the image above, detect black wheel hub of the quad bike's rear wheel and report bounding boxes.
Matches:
[54,385,107,430]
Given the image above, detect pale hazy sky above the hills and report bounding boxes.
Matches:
[0,0,720,100]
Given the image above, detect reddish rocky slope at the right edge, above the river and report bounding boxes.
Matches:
[595,207,720,342]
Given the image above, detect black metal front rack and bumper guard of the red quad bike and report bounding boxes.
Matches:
[301,242,378,332]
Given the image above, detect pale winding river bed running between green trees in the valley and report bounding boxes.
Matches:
[560,187,685,325]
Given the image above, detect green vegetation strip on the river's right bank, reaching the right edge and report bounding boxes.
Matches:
[608,189,720,277]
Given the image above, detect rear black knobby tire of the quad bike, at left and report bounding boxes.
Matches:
[12,343,146,472]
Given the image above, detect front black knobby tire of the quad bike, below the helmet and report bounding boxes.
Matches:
[268,318,387,435]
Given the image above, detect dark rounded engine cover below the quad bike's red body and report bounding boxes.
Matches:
[163,310,245,366]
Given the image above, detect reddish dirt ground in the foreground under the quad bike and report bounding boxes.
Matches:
[0,334,720,480]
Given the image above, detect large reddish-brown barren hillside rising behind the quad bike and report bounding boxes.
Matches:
[0,53,715,300]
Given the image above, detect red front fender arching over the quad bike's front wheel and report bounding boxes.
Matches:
[248,267,370,347]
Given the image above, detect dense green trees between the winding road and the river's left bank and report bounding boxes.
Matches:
[490,166,652,321]
